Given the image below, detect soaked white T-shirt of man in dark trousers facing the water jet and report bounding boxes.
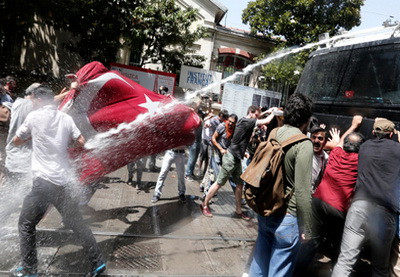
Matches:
[16,105,81,186]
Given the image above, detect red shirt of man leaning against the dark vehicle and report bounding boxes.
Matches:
[313,147,358,212]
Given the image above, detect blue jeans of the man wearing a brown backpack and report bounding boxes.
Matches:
[249,214,300,277]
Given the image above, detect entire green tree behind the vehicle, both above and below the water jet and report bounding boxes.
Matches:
[242,0,364,93]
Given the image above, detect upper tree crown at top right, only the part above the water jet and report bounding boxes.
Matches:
[242,0,364,46]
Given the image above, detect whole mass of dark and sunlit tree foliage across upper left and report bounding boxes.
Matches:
[0,0,205,74]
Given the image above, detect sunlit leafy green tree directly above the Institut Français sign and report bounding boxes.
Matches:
[127,0,206,72]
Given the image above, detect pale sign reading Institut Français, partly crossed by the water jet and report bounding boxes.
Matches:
[179,65,222,94]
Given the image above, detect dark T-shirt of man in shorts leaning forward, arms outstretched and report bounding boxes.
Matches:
[228,117,257,160]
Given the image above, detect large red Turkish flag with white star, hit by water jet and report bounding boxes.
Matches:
[59,62,200,184]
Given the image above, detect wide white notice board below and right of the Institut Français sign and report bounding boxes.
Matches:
[221,83,282,118]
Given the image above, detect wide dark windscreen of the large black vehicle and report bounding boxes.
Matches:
[297,44,400,105]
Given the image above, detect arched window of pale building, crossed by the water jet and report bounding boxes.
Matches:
[216,54,253,86]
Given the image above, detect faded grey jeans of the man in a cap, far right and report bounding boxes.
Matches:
[332,200,397,277]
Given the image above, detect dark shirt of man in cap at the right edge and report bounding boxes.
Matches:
[354,139,400,212]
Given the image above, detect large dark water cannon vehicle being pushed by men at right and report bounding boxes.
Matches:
[296,24,400,135]
